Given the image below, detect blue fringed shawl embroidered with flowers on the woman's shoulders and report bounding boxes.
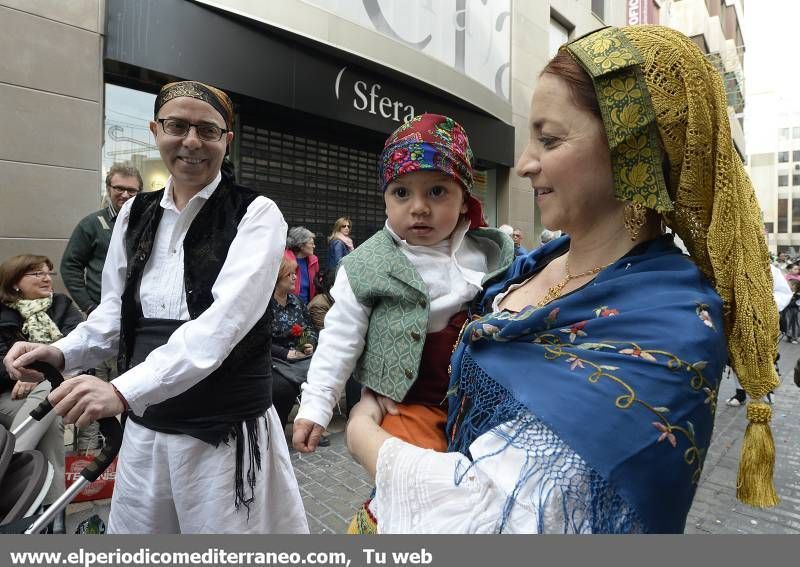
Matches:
[447,236,727,533]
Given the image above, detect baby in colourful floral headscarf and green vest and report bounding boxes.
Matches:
[293,114,514,464]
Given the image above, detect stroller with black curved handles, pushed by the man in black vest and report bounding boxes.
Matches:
[0,362,122,534]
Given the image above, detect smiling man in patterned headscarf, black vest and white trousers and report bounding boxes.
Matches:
[5,81,308,533]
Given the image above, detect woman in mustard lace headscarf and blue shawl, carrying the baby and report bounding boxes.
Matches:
[347,26,778,533]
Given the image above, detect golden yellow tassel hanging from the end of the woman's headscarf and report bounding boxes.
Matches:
[736,402,780,508]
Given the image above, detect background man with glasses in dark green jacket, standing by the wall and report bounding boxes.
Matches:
[61,164,142,315]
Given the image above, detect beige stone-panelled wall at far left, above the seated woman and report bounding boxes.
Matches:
[0,0,104,289]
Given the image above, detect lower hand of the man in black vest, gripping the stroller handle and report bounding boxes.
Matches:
[47,374,125,428]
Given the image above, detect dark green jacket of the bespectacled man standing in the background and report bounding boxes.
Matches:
[61,208,116,313]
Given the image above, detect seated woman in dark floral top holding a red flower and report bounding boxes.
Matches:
[269,257,317,427]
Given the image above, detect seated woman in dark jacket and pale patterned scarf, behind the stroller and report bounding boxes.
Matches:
[0,254,83,533]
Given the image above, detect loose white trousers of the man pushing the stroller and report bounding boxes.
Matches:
[108,407,308,534]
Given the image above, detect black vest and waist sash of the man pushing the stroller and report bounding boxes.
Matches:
[118,176,272,445]
